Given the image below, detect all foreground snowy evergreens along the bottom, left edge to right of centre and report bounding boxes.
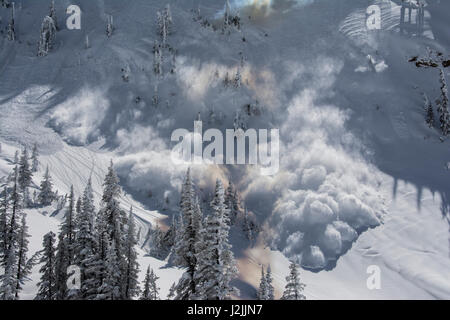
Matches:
[0,146,303,300]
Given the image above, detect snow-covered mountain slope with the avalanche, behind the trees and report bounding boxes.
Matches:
[0,0,450,299]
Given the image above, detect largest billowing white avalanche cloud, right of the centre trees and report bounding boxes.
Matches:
[241,57,384,269]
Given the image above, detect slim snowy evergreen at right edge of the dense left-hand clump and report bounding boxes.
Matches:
[124,208,139,299]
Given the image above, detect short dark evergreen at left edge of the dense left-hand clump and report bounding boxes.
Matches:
[36,232,56,300]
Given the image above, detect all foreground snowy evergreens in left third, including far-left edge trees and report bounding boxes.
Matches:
[0,152,158,300]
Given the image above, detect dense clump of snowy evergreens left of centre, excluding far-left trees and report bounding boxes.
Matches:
[32,163,146,300]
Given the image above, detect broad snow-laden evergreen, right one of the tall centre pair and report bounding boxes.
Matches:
[197,180,241,300]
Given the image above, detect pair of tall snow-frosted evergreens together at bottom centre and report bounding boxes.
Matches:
[167,170,237,300]
